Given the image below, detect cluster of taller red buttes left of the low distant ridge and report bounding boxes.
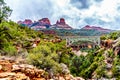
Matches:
[17,18,72,30]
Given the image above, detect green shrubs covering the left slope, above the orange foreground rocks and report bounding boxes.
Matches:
[0,21,74,74]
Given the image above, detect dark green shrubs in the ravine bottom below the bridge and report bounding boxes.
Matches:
[70,47,97,79]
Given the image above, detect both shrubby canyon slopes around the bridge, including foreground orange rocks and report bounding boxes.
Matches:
[0,21,120,80]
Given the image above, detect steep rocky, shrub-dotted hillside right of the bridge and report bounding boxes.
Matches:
[71,31,120,80]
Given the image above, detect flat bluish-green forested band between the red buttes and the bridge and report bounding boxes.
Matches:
[41,29,109,36]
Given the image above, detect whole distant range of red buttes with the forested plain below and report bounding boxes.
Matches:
[17,18,112,36]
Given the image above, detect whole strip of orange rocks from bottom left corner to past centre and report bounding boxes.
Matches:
[0,58,84,80]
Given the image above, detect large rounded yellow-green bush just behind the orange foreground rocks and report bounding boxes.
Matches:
[28,42,64,74]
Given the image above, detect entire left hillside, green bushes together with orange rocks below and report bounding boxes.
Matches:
[0,21,84,80]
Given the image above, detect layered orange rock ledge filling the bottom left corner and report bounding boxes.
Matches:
[0,60,45,80]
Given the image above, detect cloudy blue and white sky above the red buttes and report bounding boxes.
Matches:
[5,0,120,30]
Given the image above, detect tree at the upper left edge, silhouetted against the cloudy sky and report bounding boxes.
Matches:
[0,0,12,23]
